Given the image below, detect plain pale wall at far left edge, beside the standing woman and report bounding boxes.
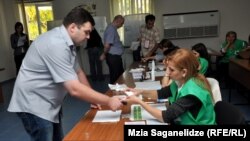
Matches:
[0,0,18,82]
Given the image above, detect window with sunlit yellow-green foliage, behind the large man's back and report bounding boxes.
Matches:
[19,2,54,40]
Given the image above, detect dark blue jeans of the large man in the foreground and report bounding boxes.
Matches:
[17,112,63,141]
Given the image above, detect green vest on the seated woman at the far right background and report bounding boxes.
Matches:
[220,39,246,63]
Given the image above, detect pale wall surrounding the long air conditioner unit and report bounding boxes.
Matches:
[155,0,250,50]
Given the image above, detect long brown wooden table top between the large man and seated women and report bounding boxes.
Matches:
[63,62,160,141]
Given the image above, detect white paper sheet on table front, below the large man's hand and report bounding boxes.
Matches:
[92,110,122,122]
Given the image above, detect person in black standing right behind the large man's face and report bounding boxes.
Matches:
[86,28,104,81]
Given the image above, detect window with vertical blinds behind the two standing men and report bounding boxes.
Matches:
[110,0,154,41]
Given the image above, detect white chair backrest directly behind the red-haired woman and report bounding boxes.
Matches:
[207,77,222,104]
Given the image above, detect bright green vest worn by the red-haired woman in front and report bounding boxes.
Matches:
[169,78,216,125]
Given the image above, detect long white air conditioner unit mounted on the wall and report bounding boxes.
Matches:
[163,10,219,39]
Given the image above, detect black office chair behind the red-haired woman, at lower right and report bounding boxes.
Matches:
[214,101,246,125]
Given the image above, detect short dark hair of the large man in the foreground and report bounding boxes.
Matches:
[63,6,95,27]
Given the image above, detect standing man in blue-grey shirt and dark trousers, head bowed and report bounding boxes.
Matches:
[100,15,125,84]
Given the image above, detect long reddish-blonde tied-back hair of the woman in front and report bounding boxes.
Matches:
[165,48,213,98]
